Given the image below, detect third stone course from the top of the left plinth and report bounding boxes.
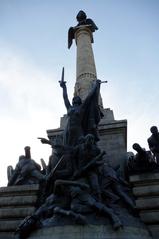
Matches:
[0,207,35,219]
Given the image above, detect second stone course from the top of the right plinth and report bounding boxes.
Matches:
[133,185,159,197]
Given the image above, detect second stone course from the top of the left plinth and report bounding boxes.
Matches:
[0,195,37,207]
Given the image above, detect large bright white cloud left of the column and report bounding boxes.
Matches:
[0,46,64,186]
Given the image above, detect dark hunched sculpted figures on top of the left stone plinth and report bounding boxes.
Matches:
[8,146,44,186]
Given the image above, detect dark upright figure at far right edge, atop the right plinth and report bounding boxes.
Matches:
[147,126,159,165]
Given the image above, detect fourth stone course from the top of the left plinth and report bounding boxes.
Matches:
[0,219,23,232]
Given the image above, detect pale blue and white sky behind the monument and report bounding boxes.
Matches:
[0,0,159,186]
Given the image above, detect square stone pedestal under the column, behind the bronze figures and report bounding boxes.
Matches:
[47,108,127,166]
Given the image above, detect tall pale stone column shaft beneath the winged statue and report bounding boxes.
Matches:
[74,25,102,105]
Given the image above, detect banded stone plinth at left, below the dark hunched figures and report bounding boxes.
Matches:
[0,185,39,239]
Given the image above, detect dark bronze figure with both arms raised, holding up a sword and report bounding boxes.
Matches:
[60,80,102,146]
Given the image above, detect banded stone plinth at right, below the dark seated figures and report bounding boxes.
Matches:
[130,173,159,239]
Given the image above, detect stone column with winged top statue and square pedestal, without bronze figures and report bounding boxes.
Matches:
[47,11,127,170]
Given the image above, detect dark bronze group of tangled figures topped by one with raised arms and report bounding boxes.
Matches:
[9,80,139,238]
